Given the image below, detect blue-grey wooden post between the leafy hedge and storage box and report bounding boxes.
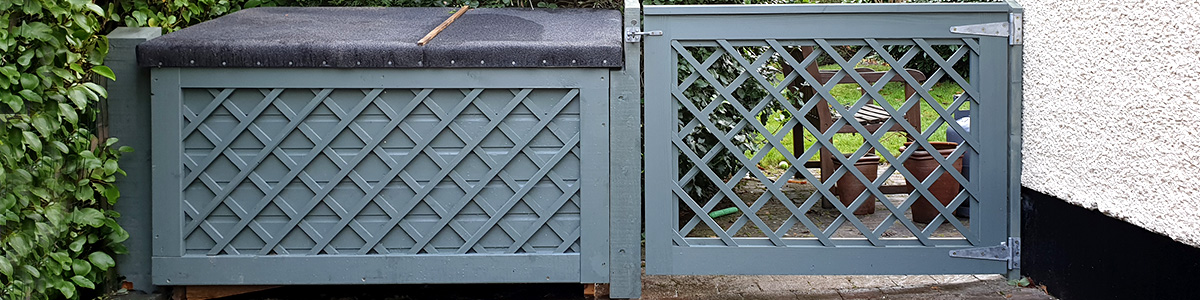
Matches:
[102,28,162,292]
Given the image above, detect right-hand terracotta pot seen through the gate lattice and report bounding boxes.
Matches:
[900,142,962,223]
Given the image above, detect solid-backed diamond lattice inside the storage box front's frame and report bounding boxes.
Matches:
[181,89,580,256]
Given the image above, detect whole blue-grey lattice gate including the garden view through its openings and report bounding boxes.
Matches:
[644,6,1010,274]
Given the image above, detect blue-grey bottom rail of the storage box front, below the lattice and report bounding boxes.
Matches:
[154,254,580,286]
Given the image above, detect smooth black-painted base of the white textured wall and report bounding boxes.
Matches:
[1021,188,1200,300]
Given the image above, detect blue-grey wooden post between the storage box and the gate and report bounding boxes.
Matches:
[608,0,642,299]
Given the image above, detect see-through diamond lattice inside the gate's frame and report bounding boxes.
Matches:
[672,38,985,246]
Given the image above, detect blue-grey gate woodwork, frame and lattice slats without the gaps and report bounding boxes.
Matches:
[644,4,1013,274]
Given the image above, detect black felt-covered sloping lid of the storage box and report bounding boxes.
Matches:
[138,7,623,67]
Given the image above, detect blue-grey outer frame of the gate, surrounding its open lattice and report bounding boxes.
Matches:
[643,0,1021,277]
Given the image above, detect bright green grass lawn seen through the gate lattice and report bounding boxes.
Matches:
[745,65,968,169]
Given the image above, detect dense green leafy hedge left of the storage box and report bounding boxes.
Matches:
[0,0,128,300]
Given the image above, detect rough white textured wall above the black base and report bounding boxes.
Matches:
[1019,0,1200,247]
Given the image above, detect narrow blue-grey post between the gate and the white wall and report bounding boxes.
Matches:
[1008,0,1025,280]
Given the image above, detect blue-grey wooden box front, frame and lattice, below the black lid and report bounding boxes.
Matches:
[152,68,611,286]
